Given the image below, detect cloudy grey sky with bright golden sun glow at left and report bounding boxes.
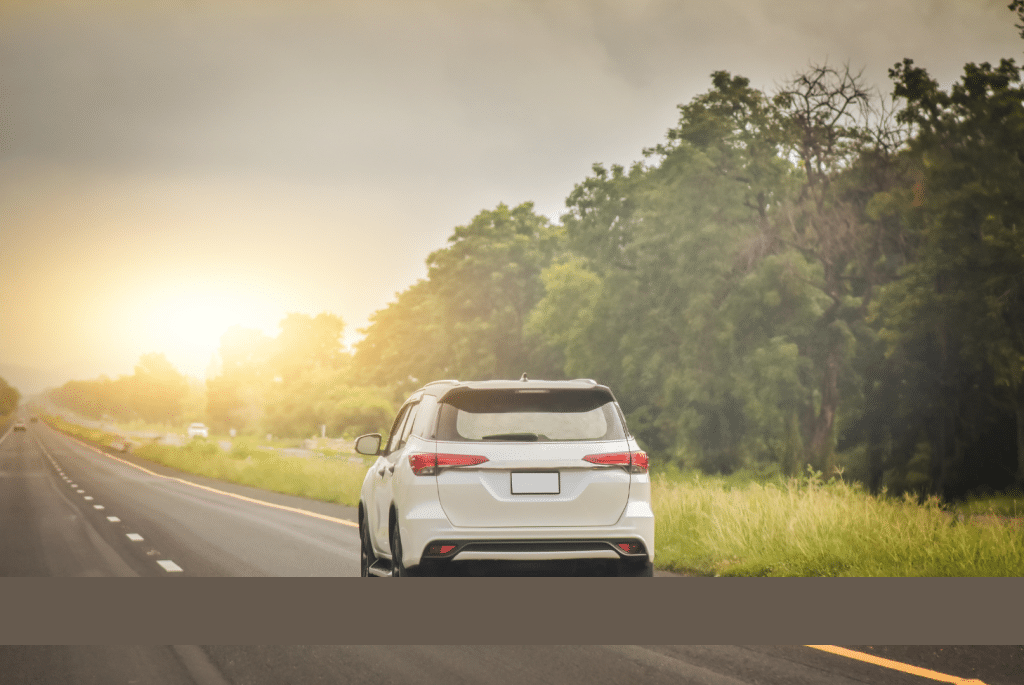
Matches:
[0,0,1024,394]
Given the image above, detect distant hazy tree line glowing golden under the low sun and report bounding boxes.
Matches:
[48,312,394,437]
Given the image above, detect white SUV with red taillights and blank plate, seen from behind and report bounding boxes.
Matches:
[355,375,654,575]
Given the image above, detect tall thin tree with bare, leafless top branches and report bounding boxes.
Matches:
[774,65,903,472]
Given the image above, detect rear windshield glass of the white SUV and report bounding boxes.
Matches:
[437,390,626,442]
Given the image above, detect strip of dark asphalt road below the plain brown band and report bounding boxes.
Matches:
[0,645,1024,685]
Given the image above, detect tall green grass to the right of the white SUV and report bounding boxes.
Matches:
[652,466,1024,576]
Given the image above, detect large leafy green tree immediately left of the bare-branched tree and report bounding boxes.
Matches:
[535,72,806,471]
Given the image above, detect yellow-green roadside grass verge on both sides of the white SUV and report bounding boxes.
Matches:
[41,417,1024,576]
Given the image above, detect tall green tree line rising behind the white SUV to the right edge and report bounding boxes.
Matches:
[352,6,1024,498]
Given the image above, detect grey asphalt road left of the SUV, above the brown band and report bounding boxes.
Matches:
[0,423,359,577]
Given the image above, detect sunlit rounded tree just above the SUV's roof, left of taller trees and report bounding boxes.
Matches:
[353,203,560,393]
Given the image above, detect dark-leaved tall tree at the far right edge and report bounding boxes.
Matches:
[879,59,1024,494]
